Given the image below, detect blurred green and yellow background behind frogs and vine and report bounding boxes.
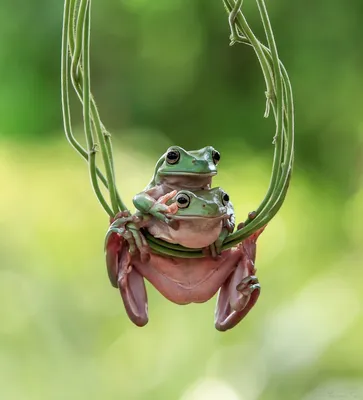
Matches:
[0,0,363,400]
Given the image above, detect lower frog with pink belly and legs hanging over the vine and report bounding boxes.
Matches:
[105,148,263,331]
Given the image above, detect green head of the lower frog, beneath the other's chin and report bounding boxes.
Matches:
[168,188,234,221]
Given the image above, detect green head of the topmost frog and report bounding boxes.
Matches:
[154,146,221,188]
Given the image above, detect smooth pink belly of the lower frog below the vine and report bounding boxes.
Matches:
[133,248,241,304]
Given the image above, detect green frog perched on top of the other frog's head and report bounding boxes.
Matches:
[133,146,219,223]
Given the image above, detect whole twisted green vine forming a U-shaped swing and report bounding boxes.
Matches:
[61,0,294,258]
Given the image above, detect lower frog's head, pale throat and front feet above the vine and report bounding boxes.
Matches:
[106,188,235,257]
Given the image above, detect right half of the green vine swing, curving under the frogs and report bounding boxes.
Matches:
[149,0,294,258]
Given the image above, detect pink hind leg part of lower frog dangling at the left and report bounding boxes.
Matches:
[117,246,149,326]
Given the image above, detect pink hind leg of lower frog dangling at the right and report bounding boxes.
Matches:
[215,228,264,331]
